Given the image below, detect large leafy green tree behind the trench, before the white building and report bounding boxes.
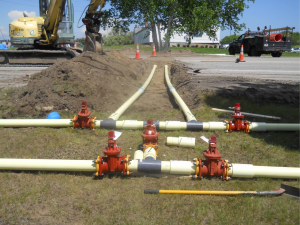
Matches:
[102,0,254,50]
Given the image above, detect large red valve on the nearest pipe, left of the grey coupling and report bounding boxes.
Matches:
[94,131,129,177]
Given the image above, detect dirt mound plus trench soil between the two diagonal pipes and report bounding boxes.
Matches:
[4,51,177,118]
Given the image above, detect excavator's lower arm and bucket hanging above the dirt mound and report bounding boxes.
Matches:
[82,0,106,53]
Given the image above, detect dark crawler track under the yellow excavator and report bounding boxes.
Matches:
[0,49,76,67]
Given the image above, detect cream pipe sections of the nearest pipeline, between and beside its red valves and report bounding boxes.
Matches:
[0,158,300,179]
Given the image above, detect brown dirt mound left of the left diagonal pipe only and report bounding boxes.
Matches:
[11,51,152,117]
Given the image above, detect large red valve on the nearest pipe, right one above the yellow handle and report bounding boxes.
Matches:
[194,135,229,180]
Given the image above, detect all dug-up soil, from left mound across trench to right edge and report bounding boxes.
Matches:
[0,49,300,120]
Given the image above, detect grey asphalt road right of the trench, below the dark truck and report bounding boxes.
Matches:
[175,55,300,81]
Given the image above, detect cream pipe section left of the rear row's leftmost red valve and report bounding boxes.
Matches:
[0,119,73,127]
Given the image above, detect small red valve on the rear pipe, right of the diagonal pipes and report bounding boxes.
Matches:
[225,103,250,133]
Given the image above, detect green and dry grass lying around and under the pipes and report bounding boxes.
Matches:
[0,94,300,224]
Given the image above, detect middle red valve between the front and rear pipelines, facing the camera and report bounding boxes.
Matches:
[142,119,159,156]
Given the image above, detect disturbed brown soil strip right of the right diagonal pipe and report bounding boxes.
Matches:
[170,62,300,108]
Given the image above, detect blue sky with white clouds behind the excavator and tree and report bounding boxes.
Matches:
[0,0,300,39]
